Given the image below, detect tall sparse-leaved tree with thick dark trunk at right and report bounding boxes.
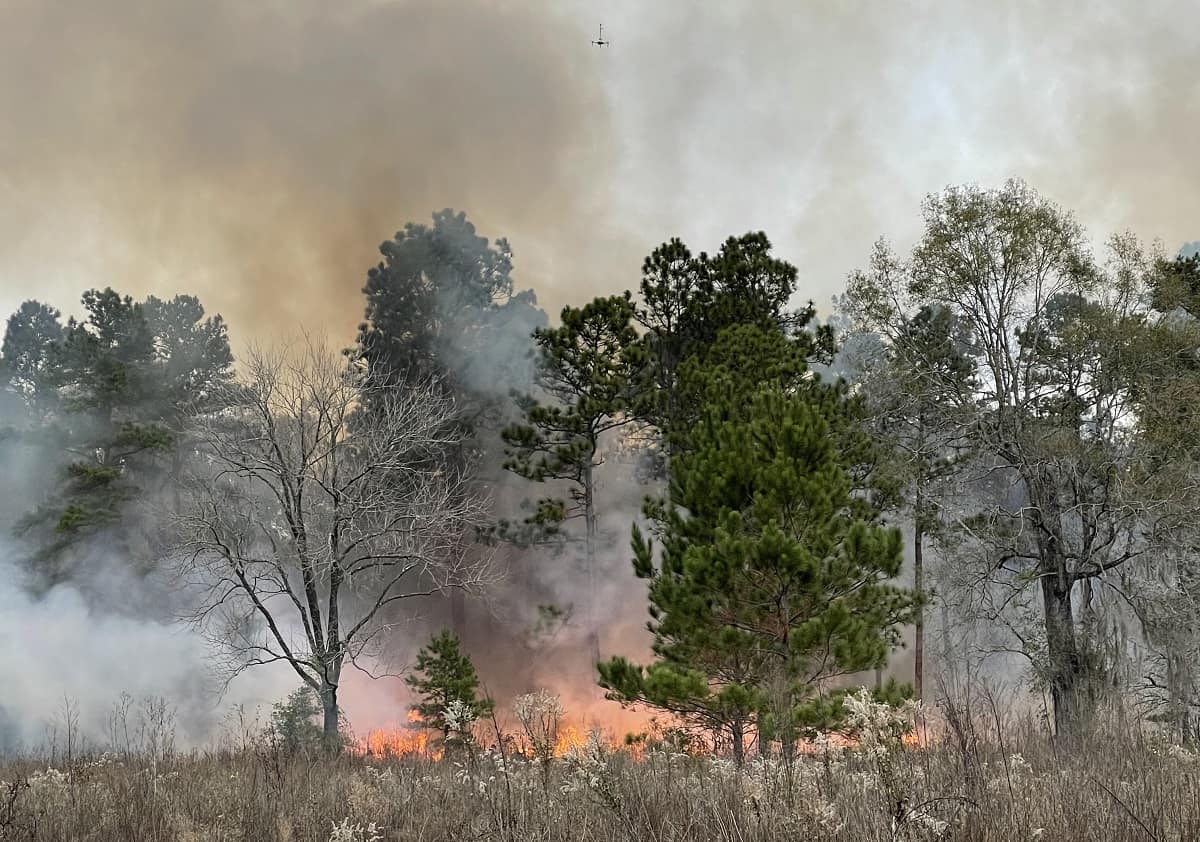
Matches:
[847,181,1198,729]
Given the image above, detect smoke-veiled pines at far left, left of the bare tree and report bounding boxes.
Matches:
[4,289,233,585]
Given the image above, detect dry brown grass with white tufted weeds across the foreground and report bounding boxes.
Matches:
[0,714,1200,842]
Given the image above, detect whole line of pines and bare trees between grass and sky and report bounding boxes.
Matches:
[0,181,1200,759]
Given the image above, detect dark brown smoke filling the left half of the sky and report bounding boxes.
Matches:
[0,0,641,339]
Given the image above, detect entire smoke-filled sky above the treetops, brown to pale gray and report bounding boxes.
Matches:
[0,0,1200,343]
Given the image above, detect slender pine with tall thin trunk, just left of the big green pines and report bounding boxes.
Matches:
[503,293,637,661]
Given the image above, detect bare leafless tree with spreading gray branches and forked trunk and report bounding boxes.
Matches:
[170,343,487,748]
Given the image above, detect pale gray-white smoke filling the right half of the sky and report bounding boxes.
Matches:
[605,0,1200,306]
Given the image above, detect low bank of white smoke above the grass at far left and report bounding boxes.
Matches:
[0,541,296,751]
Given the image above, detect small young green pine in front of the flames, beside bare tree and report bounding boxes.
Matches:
[404,630,494,741]
